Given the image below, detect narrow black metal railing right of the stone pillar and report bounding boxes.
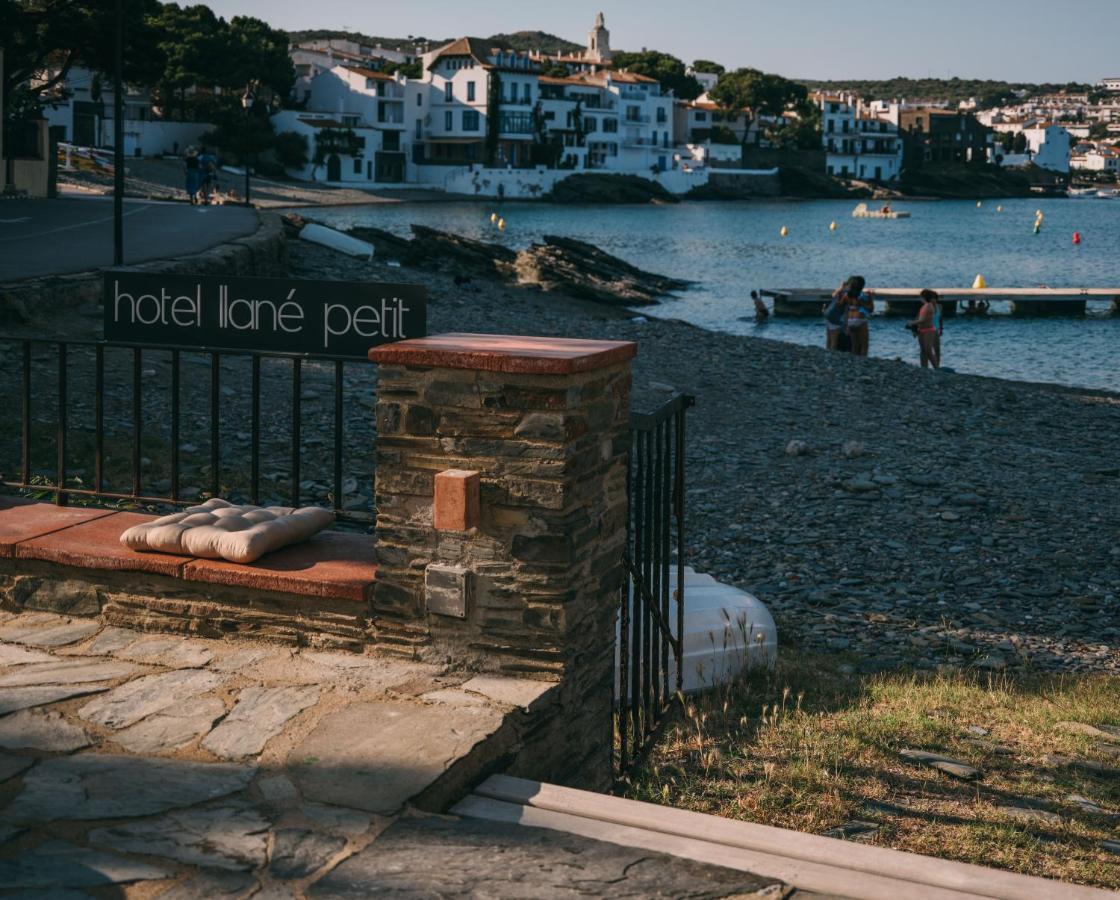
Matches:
[615,394,694,775]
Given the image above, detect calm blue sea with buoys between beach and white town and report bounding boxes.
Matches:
[314,199,1120,392]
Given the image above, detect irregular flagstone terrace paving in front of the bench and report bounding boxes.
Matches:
[0,611,753,900]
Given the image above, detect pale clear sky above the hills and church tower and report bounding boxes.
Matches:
[203,0,1120,82]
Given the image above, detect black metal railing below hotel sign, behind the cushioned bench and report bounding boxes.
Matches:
[0,338,374,524]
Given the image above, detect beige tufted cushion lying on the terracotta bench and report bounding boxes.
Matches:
[121,497,335,563]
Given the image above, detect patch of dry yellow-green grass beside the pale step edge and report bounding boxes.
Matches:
[627,653,1120,888]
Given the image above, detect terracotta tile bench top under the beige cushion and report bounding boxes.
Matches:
[0,497,376,602]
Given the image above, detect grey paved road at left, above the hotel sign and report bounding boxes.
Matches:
[0,197,258,282]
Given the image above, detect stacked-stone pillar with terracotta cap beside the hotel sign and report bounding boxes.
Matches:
[370,335,636,780]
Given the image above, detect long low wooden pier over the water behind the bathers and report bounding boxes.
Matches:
[760,288,1120,317]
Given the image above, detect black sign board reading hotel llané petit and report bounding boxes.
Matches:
[105,271,428,359]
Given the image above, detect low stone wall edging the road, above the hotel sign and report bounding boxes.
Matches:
[0,212,288,321]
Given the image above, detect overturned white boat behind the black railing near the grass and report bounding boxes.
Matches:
[615,566,777,694]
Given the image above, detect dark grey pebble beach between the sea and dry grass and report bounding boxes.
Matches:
[289,241,1120,673]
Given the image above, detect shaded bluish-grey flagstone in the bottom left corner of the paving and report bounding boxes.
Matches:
[0,841,170,898]
